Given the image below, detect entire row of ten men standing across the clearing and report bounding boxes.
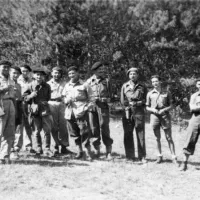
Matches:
[0,61,200,170]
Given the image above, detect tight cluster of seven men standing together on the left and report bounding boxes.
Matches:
[0,61,113,163]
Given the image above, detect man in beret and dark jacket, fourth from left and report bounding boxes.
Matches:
[24,68,52,157]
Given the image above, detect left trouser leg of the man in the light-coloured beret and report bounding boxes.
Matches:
[122,117,135,160]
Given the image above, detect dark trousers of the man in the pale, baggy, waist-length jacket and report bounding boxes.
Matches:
[67,113,91,147]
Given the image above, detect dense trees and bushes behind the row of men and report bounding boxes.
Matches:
[0,0,200,115]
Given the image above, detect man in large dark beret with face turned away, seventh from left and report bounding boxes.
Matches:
[87,62,113,160]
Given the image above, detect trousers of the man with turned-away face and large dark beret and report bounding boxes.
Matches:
[89,106,113,149]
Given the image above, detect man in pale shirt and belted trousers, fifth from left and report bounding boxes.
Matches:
[47,67,70,155]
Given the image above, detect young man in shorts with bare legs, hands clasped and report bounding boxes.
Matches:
[146,75,177,164]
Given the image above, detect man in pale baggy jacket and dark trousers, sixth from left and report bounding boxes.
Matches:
[62,66,92,160]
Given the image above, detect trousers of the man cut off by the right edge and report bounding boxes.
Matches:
[183,114,200,155]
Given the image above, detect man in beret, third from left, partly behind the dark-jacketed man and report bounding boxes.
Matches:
[14,64,35,153]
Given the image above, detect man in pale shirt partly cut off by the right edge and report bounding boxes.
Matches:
[180,79,200,171]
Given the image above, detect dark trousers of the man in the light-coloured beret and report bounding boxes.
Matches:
[122,115,146,159]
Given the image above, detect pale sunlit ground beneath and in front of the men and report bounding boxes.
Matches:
[0,120,200,200]
